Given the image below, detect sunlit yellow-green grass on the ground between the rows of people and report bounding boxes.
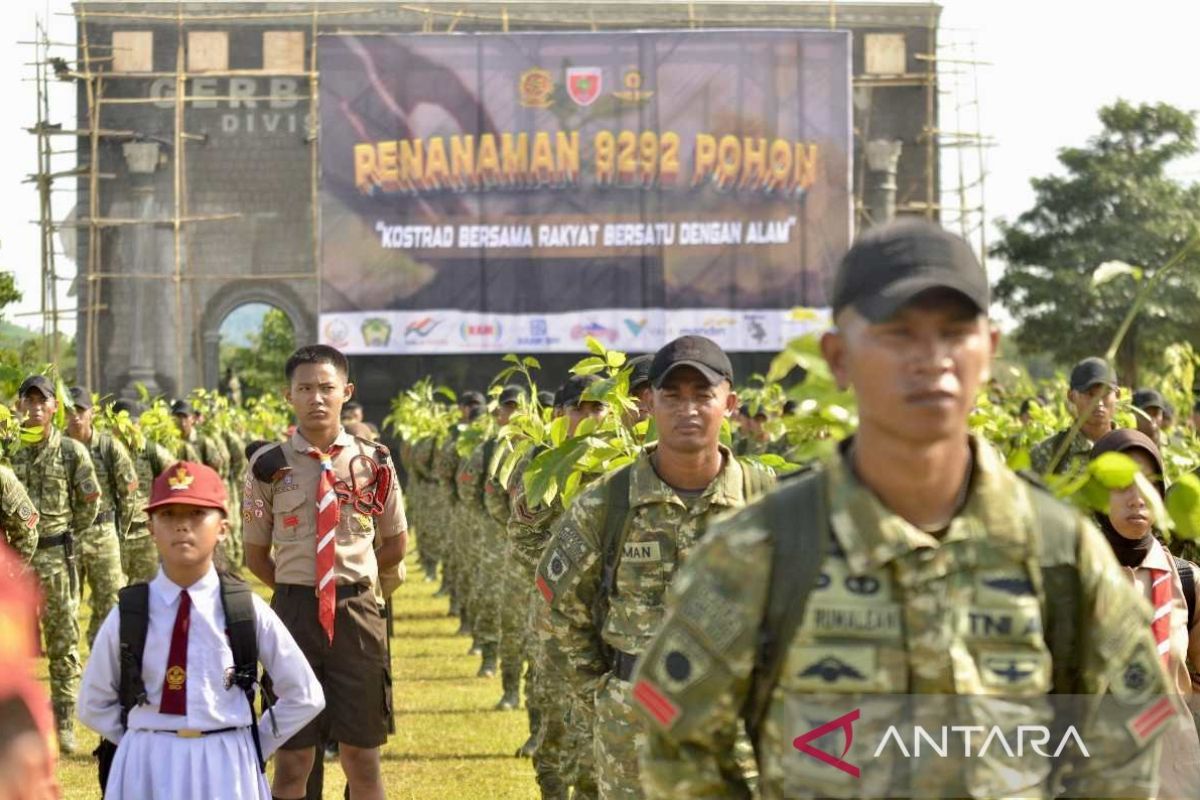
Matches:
[49,553,539,800]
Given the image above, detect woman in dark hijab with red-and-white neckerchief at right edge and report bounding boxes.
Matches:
[1091,428,1200,798]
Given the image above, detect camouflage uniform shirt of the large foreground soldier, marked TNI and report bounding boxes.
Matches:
[634,439,1170,800]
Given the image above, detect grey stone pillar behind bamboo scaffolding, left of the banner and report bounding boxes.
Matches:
[121,142,162,399]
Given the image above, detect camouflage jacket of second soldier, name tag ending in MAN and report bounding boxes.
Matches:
[535,445,777,703]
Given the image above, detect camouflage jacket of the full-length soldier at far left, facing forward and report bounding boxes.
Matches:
[12,428,100,536]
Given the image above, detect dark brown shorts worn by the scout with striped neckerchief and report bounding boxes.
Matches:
[271,584,391,758]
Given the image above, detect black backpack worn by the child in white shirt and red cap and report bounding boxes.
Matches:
[94,572,266,794]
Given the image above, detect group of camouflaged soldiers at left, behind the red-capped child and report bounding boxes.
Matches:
[0,375,245,753]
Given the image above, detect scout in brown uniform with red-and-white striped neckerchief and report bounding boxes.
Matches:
[242,344,407,800]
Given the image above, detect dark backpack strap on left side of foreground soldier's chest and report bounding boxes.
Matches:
[742,469,832,752]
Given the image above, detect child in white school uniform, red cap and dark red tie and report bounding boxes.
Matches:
[78,462,325,800]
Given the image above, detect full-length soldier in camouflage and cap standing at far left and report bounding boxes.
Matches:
[12,375,100,753]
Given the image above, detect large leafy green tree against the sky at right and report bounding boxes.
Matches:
[991,101,1200,385]
